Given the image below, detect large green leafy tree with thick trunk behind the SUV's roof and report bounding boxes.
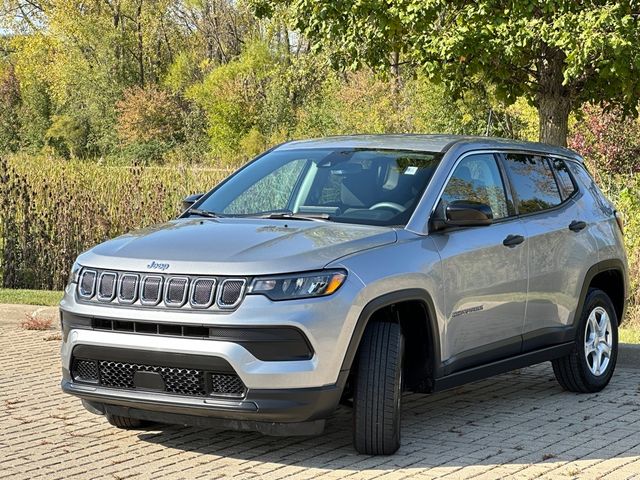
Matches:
[253,0,640,145]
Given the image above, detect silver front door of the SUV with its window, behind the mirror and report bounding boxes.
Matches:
[431,153,527,373]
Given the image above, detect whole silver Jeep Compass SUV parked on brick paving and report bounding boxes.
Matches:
[60,135,627,454]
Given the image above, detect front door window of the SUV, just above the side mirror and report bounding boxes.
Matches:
[442,154,509,219]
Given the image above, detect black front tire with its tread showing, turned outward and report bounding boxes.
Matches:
[353,322,404,455]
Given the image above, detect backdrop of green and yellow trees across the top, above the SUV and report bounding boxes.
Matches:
[0,0,640,164]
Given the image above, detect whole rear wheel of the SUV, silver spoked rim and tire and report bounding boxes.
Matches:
[552,289,618,393]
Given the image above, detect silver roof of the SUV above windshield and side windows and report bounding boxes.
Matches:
[277,134,582,161]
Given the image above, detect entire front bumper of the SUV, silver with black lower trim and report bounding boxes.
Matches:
[60,278,362,435]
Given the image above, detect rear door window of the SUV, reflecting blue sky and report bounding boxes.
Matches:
[504,153,562,214]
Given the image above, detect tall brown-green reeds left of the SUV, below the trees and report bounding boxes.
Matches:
[0,156,229,290]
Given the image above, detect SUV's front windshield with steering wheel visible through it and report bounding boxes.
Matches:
[198,148,441,226]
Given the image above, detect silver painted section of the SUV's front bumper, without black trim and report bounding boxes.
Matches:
[60,275,362,390]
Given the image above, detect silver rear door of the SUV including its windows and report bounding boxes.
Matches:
[504,153,597,351]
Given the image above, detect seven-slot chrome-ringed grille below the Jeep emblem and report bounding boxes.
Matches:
[78,269,247,310]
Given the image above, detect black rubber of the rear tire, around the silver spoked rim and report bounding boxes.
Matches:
[551,288,618,393]
